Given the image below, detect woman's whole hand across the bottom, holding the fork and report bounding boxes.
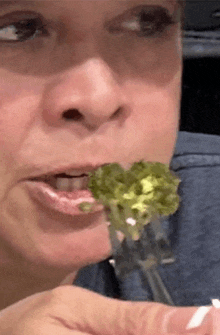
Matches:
[0,285,215,335]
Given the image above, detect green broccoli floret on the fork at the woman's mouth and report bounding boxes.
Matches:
[79,161,180,239]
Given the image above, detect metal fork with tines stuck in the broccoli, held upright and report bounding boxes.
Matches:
[109,218,175,306]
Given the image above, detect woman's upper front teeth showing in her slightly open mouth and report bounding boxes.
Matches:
[50,177,89,192]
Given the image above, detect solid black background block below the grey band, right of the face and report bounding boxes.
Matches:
[180,57,220,135]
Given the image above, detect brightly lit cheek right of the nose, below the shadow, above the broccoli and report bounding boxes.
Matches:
[123,73,181,164]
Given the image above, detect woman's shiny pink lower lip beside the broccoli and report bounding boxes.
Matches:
[25,181,104,216]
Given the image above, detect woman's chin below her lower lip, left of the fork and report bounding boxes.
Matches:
[31,223,112,272]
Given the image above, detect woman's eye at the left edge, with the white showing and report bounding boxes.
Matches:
[0,18,48,43]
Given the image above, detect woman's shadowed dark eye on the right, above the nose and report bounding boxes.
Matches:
[109,6,178,38]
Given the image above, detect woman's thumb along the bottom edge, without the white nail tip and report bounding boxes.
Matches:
[52,286,211,335]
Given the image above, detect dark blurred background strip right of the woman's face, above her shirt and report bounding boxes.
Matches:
[180,0,220,135]
